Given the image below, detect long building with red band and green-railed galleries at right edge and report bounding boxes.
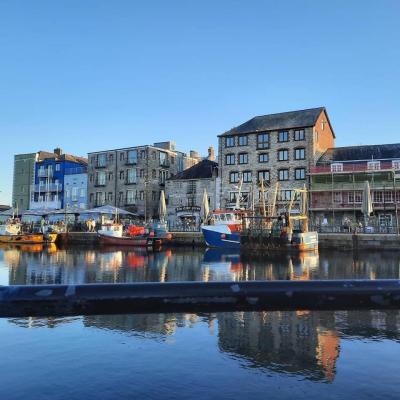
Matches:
[310,143,400,228]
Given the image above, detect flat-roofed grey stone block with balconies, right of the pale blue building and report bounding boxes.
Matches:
[88,141,201,220]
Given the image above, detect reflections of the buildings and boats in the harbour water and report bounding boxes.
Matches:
[0,245,400,382]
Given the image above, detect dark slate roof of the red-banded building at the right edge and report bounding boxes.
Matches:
[317,143,400,165]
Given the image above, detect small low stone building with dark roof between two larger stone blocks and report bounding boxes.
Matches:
[165,147,220,228]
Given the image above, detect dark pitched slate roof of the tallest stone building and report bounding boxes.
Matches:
[220,107,333,136]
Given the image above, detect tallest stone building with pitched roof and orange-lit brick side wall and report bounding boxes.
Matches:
[219,107,335,210]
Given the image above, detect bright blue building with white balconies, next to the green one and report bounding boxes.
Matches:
[29,148,87,210]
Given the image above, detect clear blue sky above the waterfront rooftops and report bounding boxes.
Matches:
[0,0,400,203]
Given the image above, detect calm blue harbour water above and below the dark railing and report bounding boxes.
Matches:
[0,247,400,400]
